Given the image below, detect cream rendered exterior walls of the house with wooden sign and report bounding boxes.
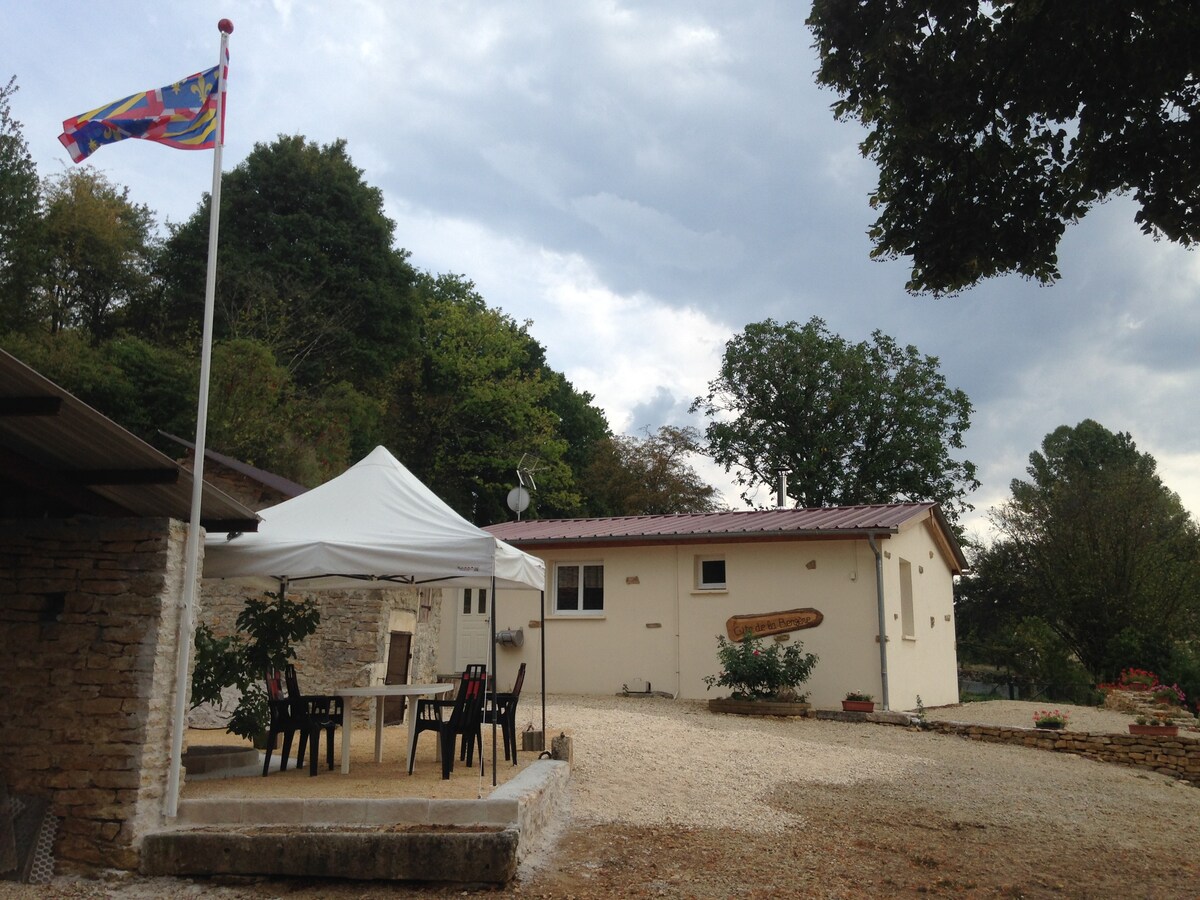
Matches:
[438,522,958,720]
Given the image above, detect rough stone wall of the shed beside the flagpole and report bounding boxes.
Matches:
[0,518,186,871]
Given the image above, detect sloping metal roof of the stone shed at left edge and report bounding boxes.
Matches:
[0,350,258,532]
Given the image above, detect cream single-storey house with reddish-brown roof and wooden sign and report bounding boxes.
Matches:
[438,503,966,709]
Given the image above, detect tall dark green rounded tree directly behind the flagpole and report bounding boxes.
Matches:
[150,136,415,389]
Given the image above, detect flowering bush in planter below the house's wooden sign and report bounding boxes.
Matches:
[704,631,817,715]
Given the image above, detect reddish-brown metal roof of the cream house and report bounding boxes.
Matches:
[487,503,966,571]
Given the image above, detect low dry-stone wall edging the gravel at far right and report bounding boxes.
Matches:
[925,721,1200,785]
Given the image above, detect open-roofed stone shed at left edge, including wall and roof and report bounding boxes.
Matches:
[0,352,257,877]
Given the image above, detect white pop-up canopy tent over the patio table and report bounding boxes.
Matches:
[203,446,546,781]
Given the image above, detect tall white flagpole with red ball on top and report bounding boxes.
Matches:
[166,19,233,818]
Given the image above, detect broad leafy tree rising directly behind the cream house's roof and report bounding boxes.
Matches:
[691,318,979,522]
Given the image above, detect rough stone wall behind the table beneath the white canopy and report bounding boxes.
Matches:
[198,581,440,725]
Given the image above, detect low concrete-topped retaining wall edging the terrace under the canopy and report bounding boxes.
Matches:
[142,760,570,884]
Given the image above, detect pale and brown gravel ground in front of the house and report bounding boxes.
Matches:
[0,697,1200,900]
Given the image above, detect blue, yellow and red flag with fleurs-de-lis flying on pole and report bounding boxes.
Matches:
[59,52,229,162]
